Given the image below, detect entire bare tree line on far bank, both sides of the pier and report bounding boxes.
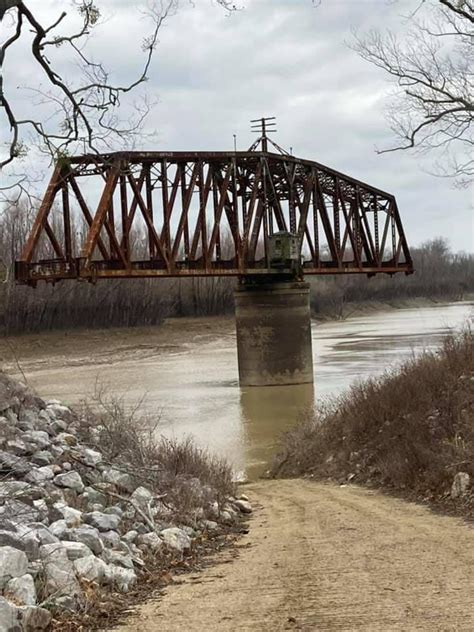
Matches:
[0,204,474,335]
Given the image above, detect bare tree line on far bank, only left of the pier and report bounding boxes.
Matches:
[0,203,233,334]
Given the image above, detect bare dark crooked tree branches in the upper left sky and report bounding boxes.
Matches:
[0,0,236,198]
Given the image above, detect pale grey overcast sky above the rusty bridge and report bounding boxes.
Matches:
[3,0,474,251]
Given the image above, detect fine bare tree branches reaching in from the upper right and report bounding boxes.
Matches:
[354,0,474,186]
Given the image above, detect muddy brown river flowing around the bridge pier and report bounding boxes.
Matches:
[0,302,474,478]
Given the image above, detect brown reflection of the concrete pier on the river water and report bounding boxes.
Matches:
[240,384,314,478]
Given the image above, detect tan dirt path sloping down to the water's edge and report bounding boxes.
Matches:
[112,480,474,632]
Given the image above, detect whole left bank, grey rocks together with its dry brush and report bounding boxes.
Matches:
[0,372,252,632]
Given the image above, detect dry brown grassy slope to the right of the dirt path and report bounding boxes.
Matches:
[273,328,474,507]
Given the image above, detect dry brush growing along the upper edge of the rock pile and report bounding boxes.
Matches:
[79,388,236,523]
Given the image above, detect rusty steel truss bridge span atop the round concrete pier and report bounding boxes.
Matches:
[15,123,413,285]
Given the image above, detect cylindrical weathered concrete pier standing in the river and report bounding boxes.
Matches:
[234,281,313,386]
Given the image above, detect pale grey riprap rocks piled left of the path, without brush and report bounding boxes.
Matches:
[0,374,251,632]
